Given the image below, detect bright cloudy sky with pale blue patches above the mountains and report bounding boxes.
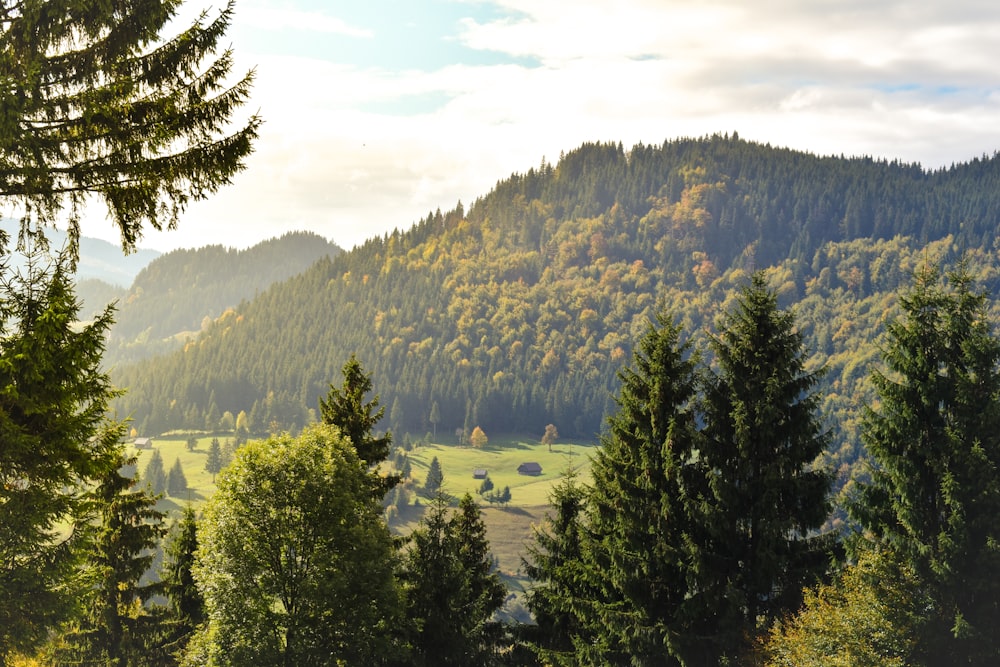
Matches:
[76,0,1000,251]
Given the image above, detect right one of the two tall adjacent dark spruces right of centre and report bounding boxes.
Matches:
[698,272,831,659]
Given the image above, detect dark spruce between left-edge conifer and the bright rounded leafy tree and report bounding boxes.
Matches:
[62,456,166,667]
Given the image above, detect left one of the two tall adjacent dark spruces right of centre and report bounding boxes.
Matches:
[580,314,698,665]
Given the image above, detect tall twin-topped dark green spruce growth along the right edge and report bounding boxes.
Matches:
[851,266,1000,665]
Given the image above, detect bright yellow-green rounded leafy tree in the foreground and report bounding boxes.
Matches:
[187,425,400,665]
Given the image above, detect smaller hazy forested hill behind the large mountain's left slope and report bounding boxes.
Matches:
[101,232,341,366]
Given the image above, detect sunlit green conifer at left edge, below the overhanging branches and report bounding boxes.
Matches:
[0,254,124,663]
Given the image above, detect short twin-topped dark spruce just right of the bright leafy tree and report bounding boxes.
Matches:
[402,494,505,666]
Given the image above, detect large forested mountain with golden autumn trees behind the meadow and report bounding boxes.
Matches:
[115,135,1000,470]
